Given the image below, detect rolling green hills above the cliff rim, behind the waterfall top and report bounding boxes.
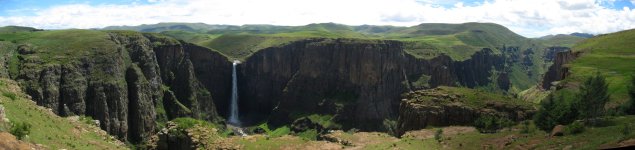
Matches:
[112,23,532,60]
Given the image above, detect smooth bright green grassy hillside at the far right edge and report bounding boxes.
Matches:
[564,30,635,106]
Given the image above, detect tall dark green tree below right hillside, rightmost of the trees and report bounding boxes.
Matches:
[576,73,609,125]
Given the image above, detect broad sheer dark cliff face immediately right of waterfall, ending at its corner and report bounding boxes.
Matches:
[239,39,404,129]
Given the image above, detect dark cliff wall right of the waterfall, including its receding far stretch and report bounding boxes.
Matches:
[239,39,508,130]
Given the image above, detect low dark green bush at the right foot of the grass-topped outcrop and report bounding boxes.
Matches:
[474,115,513,133]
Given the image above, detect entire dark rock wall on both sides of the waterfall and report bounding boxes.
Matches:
[5,32,509,142]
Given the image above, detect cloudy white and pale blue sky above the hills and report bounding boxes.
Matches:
[0,0,635,37]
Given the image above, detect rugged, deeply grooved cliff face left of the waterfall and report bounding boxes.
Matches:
[13,32,230,142]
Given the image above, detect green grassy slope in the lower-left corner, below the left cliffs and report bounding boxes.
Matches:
[0,79,126,149]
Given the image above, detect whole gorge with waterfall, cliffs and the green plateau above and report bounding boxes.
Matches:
[0,23,632,148]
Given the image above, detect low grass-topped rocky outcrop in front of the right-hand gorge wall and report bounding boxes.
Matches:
[397,87,533,135]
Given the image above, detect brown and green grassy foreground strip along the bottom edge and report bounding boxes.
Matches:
[176,116,635,150]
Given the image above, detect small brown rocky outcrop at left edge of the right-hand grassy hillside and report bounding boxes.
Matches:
[541,51,579,90]
